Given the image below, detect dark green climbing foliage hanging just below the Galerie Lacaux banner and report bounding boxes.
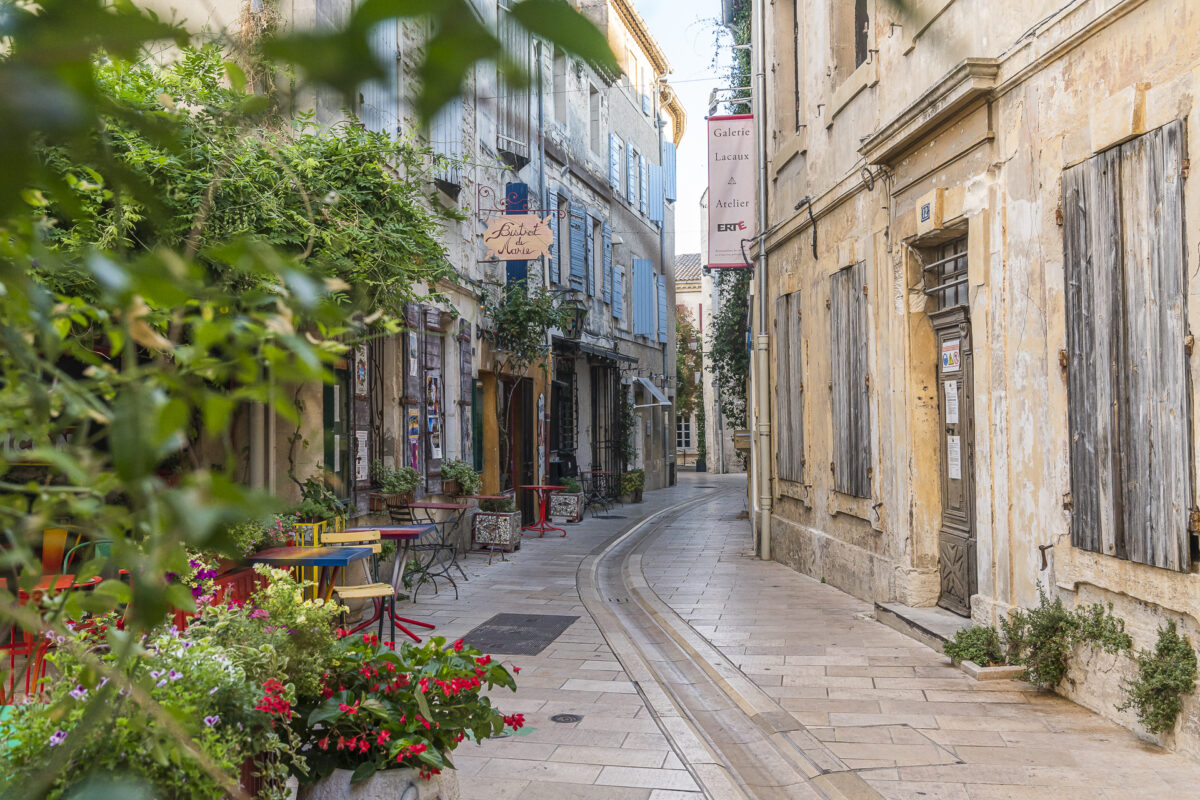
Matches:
[706,270,751,428]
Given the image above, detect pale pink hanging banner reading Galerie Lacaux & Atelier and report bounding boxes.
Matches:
[708,114,755,269]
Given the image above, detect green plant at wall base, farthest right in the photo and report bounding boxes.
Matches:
[1117,620,1196,733]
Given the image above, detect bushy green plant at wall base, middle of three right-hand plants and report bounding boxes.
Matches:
[1001,583,1133,688]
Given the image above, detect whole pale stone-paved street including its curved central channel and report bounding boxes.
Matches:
[415,473,1200,800]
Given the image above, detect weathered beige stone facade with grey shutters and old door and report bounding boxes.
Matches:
[766,0,1200,754]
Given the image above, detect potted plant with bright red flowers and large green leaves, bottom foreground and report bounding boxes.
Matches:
[292,633,524,800]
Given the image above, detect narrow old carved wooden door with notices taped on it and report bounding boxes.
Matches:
[925,239,977,615]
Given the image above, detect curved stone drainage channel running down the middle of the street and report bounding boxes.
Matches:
[578,492,881,800]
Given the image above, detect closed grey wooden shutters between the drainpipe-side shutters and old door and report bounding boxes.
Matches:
[829,261,871,498]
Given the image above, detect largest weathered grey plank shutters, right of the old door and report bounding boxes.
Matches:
[1062,121,1194,571]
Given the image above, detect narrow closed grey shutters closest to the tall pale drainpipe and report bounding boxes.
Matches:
[775,291,801,483]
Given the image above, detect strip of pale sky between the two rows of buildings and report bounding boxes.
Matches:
[634,0,730,253]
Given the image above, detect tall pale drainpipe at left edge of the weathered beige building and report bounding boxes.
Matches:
[750,0,772,561]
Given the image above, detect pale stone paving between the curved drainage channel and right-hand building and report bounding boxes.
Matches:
[642,474,1200,800]
